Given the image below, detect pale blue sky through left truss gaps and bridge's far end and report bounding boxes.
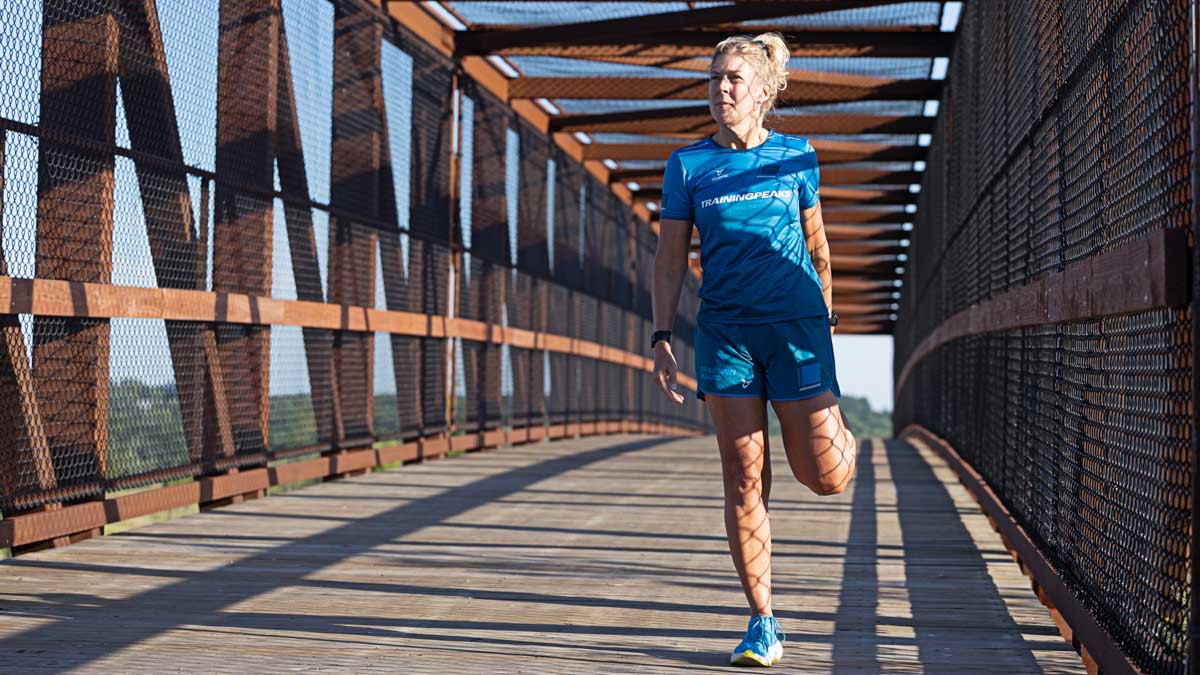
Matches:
[0,0,892,410]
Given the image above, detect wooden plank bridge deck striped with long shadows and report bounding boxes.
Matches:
[0,436,1084,674]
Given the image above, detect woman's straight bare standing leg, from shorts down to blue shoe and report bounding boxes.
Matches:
[706,394,772,614]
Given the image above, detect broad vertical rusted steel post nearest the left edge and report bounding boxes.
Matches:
[32,0,119,494]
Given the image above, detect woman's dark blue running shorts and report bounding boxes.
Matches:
[695,316,841,401]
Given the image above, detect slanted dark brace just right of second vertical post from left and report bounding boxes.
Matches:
[275,7,340,443]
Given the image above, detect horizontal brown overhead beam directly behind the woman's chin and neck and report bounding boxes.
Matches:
[550,111,935,138]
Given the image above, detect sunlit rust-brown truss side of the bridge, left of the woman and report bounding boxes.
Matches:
[0,0,706,549]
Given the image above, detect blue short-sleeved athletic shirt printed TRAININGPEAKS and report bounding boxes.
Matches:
[661,131,828,323]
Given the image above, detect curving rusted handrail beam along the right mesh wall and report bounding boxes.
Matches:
[895,228,1189,395]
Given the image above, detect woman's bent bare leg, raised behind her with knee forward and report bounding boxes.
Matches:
[772,392,858,495]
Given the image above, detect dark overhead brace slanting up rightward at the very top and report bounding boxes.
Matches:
[455,0,916,56]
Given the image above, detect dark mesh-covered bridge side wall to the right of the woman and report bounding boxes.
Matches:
[895,0,1196,673]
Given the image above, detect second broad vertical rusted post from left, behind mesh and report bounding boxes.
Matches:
[213,0,282,454]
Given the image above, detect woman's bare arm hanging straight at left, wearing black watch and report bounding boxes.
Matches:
[650,219,691,404]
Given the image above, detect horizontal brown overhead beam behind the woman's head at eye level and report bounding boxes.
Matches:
[509,77,942,102]
